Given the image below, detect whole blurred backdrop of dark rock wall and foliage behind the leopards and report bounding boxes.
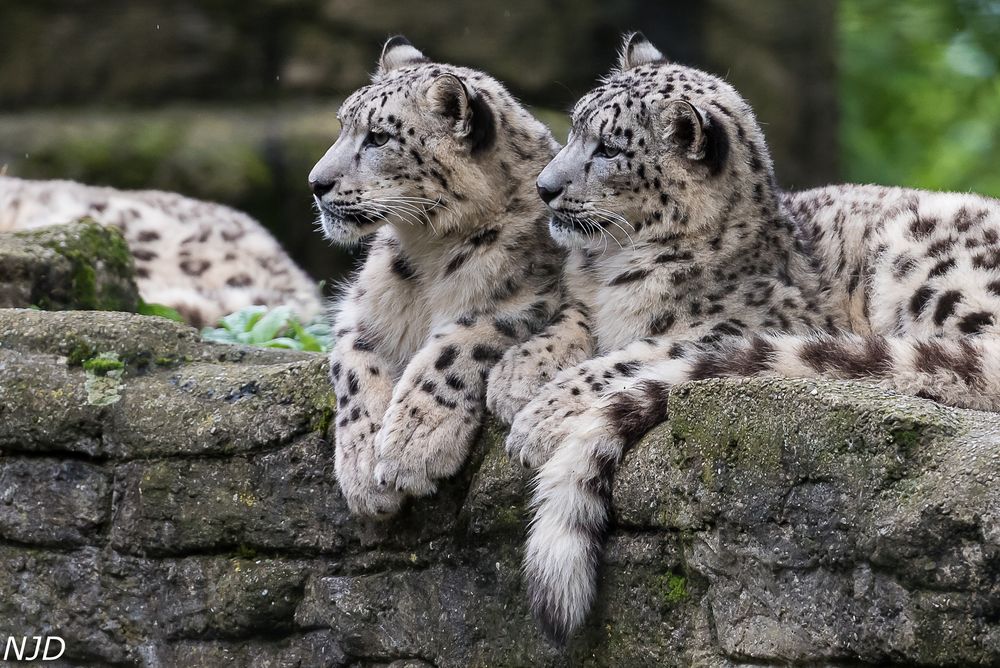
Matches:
[0,0,1000,280]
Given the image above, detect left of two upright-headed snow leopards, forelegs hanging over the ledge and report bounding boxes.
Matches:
[309,36,563,518]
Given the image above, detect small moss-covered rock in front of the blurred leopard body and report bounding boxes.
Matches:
[0,219,139,311]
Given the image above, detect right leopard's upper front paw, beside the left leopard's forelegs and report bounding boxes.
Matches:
[486,339,586,424]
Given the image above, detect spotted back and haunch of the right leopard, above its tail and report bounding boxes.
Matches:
[782,185,1000,337]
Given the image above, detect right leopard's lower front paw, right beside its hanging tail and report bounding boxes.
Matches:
[506,382,596,468]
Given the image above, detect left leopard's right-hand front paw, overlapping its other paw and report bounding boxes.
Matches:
[374,389,481,496]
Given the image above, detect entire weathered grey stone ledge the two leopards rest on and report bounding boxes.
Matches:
[0,310,1000,668]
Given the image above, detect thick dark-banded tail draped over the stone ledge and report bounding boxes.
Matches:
[525,334,1000,643]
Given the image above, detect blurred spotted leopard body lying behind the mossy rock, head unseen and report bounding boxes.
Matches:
[0,176,322,327]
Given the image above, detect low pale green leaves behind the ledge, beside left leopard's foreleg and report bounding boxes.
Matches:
[201,306,333,352]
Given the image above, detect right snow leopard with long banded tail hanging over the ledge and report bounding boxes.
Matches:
[490,33,1000,642]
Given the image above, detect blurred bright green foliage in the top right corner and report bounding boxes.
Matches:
[839,0,1000,196]
